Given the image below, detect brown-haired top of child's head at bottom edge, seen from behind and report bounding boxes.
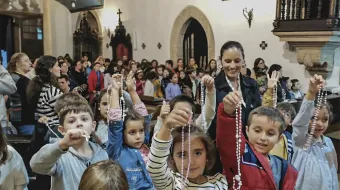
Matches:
[78,160,129,190]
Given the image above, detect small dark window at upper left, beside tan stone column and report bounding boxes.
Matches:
[22,18,43,40]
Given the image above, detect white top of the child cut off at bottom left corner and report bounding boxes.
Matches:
[0,145,29,190]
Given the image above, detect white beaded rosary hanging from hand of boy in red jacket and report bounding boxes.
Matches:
[226,77,245,190]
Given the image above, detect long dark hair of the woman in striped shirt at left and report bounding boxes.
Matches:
[26,55,59,111]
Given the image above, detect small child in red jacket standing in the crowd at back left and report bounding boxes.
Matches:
[87,62,104,105]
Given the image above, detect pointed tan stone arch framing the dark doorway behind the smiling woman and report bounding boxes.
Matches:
[170,5,215,66]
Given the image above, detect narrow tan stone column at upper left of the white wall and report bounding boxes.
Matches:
[43,0,52,55]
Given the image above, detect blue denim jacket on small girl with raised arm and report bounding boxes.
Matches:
[107,115,153,190]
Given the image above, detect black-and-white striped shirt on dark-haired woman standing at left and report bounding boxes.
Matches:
[35,85,63,127]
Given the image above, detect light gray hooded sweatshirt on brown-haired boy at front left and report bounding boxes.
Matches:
[30,142,109,190]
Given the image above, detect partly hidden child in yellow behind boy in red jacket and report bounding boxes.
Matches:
[269,102,296,163]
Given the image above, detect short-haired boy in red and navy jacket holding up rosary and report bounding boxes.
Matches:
[216,92,298,190]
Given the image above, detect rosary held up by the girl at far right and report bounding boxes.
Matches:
[303,87,327,151]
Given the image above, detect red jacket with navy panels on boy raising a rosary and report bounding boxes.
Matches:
[216,103,298,190]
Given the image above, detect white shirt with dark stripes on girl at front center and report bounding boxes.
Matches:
[147,133,228,190]
